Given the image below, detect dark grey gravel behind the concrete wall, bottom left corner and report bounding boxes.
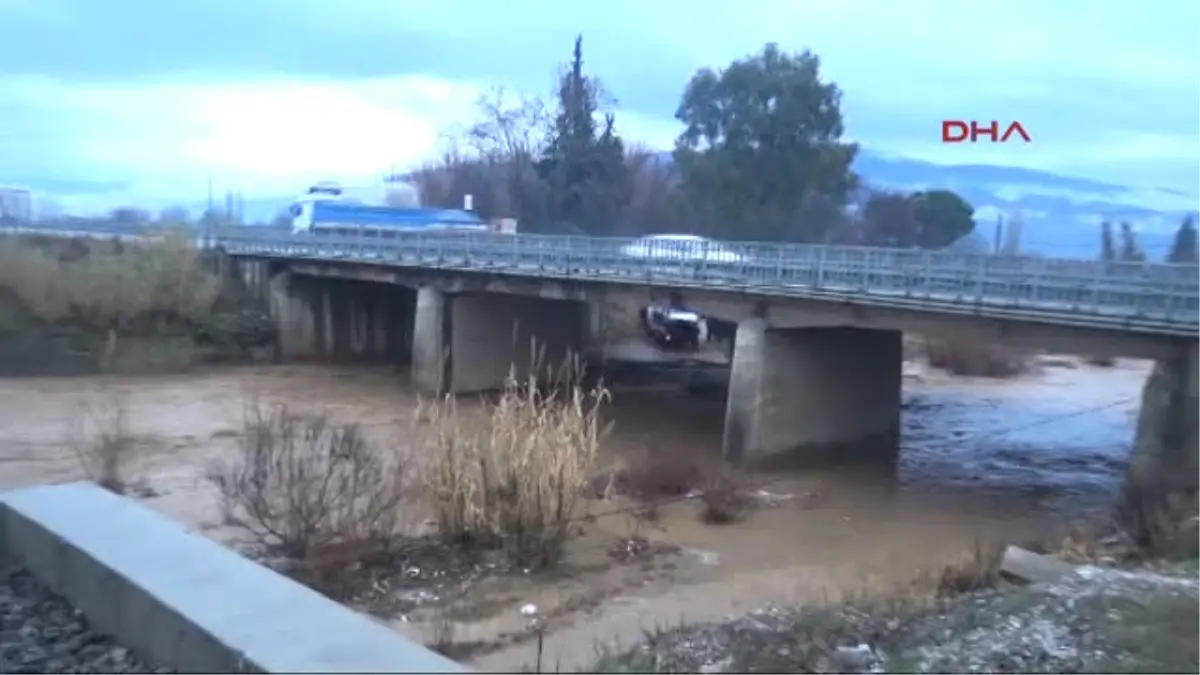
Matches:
[0,568,170,673]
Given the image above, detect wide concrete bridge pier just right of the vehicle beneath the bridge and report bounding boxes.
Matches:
[724,318,902,466]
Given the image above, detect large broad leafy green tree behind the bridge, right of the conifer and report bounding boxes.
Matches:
[674,44,858,241]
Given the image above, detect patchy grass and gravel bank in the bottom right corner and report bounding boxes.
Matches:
[594,567,1200,673]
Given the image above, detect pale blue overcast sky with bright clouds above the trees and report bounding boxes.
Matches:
[0,0,1200,210]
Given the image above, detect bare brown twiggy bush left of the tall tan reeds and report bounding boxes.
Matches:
[208,404,410,557]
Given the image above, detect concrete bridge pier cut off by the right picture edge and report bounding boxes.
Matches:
[1129,342,1200,490]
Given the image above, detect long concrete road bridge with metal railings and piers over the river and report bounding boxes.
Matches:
[189,229,1200,473]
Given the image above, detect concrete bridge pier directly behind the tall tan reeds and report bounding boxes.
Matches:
[413,286,594,394]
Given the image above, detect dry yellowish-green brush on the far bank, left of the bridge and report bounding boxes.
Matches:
[0,233,218,330]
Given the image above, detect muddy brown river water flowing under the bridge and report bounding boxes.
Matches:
[0,363,1148,670]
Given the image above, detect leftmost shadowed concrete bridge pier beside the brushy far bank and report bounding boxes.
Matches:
[268,271,415,364]
